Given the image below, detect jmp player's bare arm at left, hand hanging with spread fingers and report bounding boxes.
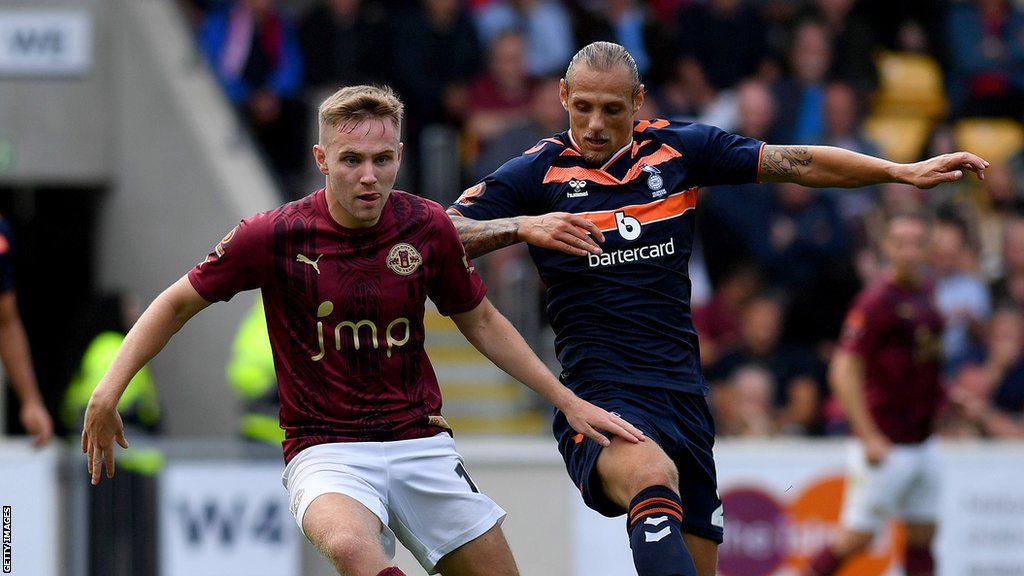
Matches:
[82,276,210,484]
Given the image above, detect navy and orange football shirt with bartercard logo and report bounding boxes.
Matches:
[450,120,764,394]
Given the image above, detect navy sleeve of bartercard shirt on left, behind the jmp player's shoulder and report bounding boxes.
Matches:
[449,156,541,220]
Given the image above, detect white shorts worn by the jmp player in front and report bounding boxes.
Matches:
[281,433,506,574]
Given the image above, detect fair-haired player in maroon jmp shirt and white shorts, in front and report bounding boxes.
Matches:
[82,86,643,576]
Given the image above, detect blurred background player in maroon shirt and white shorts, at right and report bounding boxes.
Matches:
[806,213,944,576]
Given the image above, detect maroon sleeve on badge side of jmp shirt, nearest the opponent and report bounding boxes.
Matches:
[427,207,487,316]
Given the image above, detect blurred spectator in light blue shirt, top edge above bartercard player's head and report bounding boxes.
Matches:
[476,0,575,76]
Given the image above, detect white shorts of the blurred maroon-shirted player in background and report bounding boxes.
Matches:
[843,439,941,533]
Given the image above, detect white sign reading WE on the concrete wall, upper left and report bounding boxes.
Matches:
[0,8,93,76]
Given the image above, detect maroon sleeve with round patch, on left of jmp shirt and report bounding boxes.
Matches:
[188,215,270,302]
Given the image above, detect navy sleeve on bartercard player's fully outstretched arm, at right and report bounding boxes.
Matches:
[679,124,764,186]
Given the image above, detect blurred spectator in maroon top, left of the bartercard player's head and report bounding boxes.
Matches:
[466,31,528,150]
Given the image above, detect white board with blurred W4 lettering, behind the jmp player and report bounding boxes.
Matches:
[160,461,299,576]
